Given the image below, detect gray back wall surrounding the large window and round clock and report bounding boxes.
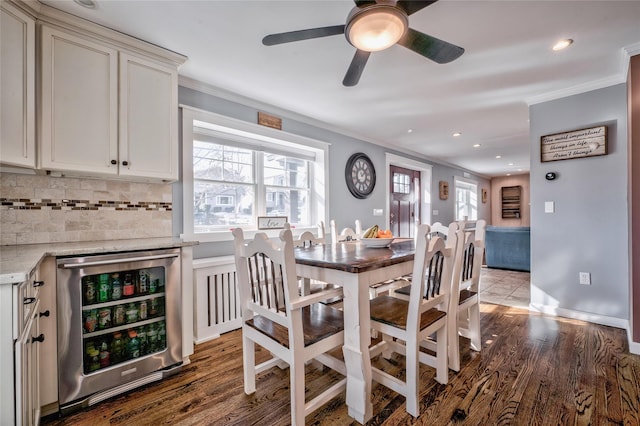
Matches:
[173,86,491,259]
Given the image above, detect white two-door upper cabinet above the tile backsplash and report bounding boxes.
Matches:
[39,8,186,181]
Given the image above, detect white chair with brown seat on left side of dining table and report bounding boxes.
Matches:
[232,228,346,425]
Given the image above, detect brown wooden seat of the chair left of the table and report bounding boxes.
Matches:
[246,303,344,348]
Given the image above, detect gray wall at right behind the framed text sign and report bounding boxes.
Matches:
[530,84,629,320]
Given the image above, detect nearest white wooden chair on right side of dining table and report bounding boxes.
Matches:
[370,225,457,417]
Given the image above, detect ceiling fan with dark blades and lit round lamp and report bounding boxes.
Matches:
[262,0,464,86]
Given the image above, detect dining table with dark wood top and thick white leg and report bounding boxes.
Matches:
[294,238,415,424]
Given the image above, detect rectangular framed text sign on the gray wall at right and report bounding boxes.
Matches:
[540,126,608,163]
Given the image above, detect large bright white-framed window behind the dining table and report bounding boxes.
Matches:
[183,108,328,241]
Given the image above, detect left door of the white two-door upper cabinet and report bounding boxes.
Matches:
[40,27,118,175]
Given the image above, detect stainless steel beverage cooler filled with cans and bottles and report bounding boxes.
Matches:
[57,249,182,413]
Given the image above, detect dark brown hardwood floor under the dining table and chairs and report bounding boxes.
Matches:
[42,274,640,426]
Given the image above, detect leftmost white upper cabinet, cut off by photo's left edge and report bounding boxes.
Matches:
[0,1,36,168]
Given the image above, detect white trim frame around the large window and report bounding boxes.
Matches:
[180,105,331,242]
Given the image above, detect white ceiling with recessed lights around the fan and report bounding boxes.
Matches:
[42,0,640,176]
